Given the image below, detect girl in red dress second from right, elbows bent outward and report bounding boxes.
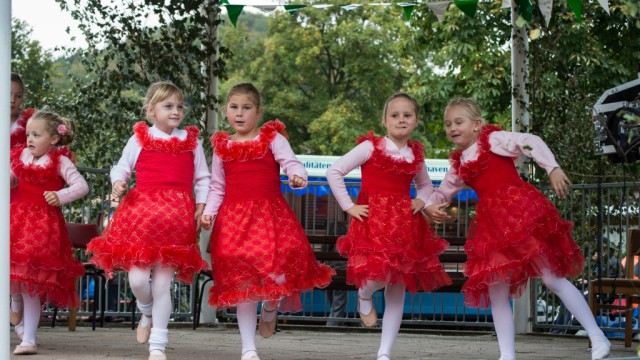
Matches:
[327,93,451,360]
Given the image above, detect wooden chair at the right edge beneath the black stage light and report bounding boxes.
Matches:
[589,229,640,347]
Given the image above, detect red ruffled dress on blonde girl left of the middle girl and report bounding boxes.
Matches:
[87,122,209,283]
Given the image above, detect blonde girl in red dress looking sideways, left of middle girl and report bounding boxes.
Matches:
[87,82,209,360]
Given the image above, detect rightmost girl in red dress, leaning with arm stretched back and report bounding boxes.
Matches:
[426,99,611,360]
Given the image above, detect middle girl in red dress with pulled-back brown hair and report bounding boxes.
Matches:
[202,83,334,360]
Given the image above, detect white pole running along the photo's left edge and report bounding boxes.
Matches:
[0,0,11,359]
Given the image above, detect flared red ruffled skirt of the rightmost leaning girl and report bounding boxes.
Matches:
[462,182,584,308]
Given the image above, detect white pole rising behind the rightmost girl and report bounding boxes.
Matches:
[511,1,531,334]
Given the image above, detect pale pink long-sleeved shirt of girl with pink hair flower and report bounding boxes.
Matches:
[11,148,89,205]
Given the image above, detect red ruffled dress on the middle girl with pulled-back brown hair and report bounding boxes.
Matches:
[209,121,335,311]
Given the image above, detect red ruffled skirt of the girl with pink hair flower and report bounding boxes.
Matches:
[10,200,84,307]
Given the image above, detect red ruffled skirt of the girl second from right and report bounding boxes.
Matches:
[337,192,451,293]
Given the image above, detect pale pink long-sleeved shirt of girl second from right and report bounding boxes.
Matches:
[327,137,433,211]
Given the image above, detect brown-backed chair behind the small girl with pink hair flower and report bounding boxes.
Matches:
[51,222,135,331]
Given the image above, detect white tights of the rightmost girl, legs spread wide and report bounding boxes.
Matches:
[489,269,604,360]
